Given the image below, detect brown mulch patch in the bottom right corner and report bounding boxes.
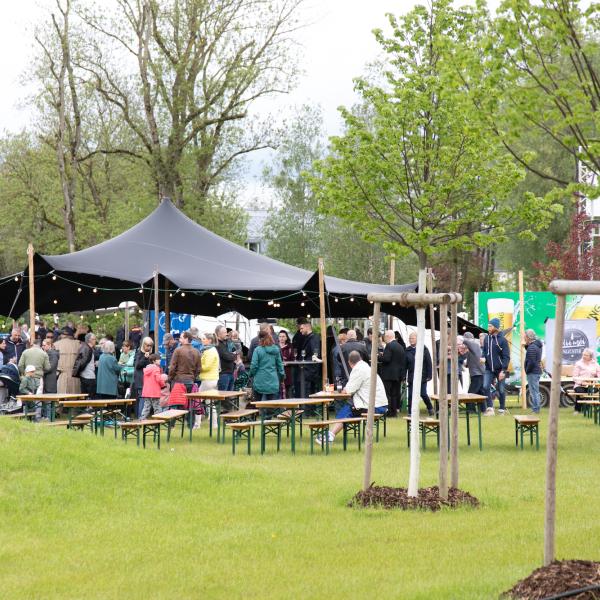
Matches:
[502,560,600,600]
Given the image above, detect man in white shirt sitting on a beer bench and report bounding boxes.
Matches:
[317,350,388,443]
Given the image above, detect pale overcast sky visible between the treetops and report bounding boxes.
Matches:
[0,0,488,203]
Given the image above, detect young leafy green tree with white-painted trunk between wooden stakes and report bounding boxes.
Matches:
[312,0,554,496]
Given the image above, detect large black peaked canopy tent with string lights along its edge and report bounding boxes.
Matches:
[0,199,477,329]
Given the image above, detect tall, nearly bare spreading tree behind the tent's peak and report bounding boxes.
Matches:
[80,0,301,207]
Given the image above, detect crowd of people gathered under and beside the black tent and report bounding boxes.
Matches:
[0,319,552,426]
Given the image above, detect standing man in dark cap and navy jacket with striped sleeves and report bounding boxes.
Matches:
[483,318,510,417]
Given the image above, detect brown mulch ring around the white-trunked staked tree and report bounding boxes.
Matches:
[348,484,479,512]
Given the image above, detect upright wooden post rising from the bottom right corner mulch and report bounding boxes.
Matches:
[544,292,568,566]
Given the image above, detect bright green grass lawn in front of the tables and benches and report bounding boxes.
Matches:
[0,398,600,600]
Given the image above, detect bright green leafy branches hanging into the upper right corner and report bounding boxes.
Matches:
[490,0,600,186]
